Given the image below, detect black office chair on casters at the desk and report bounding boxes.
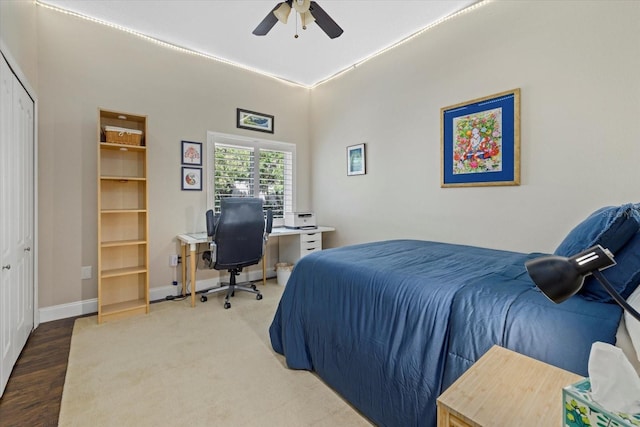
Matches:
[200,197,273,308]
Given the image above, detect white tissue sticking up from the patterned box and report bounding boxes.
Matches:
[589,342,640,414]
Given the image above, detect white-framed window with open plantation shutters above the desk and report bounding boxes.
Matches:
[207,132,295,225]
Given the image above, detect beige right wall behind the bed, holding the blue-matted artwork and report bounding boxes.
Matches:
[311,1,640,252]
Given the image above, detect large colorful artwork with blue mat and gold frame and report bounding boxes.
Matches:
[440,89,520,187]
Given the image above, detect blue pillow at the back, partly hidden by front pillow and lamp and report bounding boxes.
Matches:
[553,203,640,257]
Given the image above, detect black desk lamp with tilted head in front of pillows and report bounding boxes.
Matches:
[524,245,640,321]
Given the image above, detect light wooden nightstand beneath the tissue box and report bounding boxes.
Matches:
[437,346,583,427]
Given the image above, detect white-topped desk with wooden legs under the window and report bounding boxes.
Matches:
[177,226,335,307]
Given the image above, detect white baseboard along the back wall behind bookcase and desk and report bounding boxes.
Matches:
[38,270,276,323]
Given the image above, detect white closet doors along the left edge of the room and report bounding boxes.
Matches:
[0,56,35,396]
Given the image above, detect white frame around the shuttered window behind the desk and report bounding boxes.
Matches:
[206,131,296,227]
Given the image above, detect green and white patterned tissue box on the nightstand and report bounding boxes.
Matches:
[562,378,640,427]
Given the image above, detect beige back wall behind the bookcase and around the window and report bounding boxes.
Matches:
[38,7,310,307]
